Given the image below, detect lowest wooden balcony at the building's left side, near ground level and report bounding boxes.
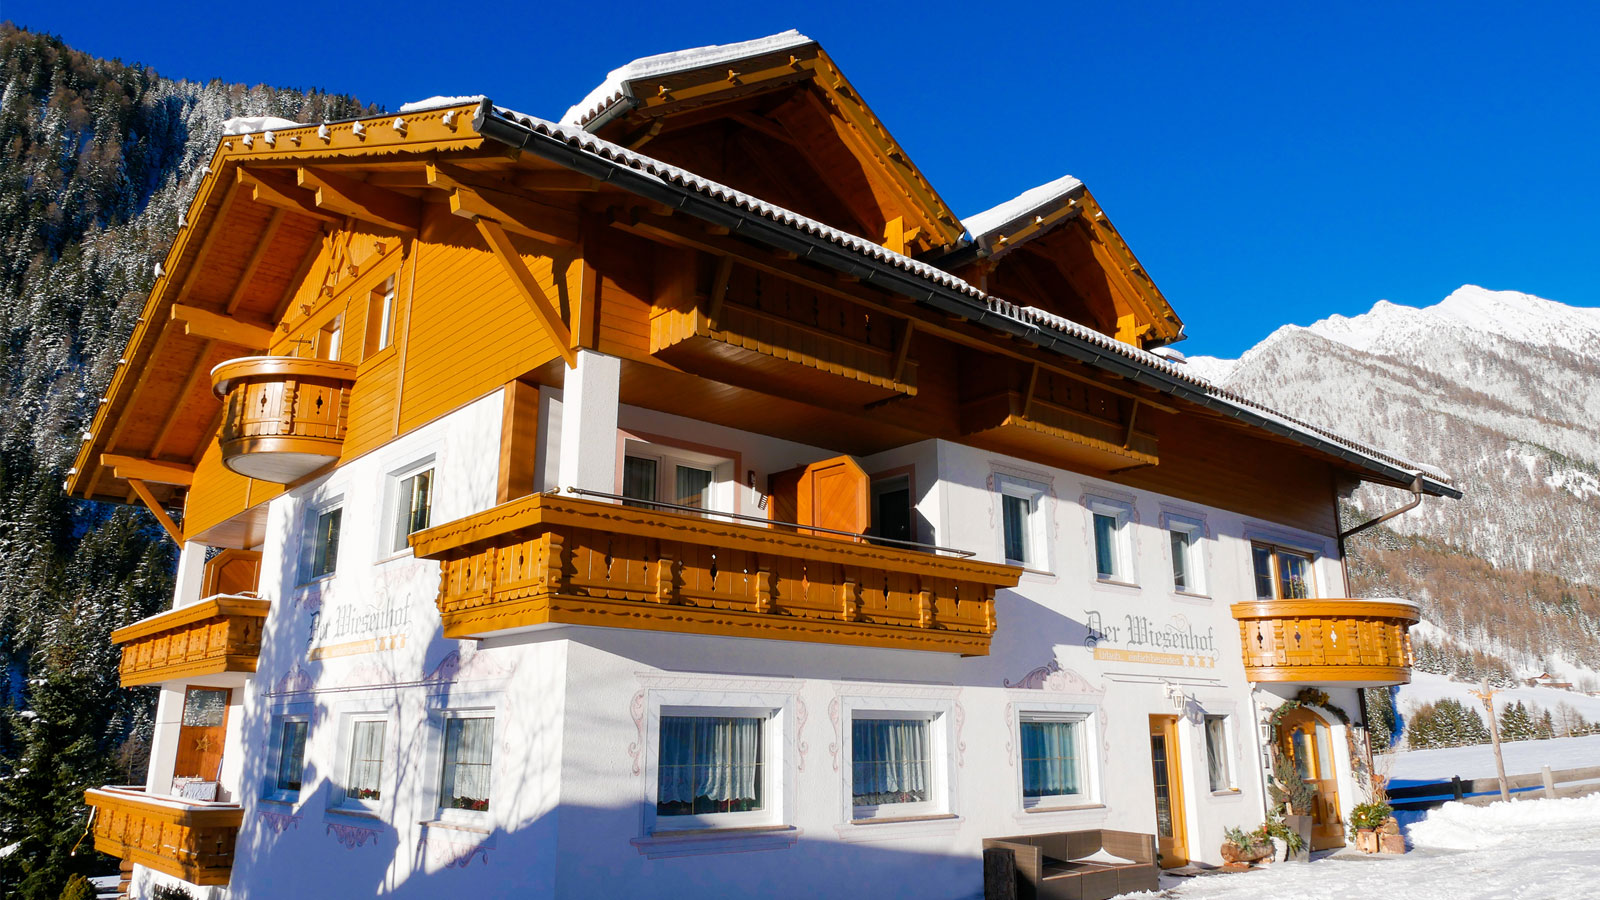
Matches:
[83,786,245,886]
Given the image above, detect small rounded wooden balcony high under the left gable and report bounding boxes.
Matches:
[211,356,355,484]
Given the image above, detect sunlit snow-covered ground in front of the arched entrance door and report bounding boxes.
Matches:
[1128,796,1600,900]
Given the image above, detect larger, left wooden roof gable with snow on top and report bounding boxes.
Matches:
[586,42,963,255]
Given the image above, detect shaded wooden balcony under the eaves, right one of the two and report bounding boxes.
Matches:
[962,391,1160,472]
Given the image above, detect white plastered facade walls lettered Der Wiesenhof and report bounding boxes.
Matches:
[134,374,1362,898]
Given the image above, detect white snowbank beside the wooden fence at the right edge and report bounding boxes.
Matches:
[1410,794,1600,850]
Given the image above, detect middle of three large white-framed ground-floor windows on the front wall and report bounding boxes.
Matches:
[850,709,946,820]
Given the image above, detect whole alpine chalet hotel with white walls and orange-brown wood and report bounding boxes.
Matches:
[67,32,1459,900]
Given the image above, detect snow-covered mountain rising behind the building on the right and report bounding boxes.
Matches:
[1189,285,1600,669]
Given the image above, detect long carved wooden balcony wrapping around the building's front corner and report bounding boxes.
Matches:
[411,495,1021,655]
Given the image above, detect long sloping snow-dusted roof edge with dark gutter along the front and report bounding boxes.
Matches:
[476,106,1454,492]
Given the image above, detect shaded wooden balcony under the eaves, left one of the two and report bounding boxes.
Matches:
[650,267,917,405]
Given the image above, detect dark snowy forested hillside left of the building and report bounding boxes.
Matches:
[0,24,376,900]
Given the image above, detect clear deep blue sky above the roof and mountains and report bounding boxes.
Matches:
[0,0,1600,356]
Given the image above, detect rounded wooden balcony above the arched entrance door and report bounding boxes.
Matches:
[1232,599,1419,687]
